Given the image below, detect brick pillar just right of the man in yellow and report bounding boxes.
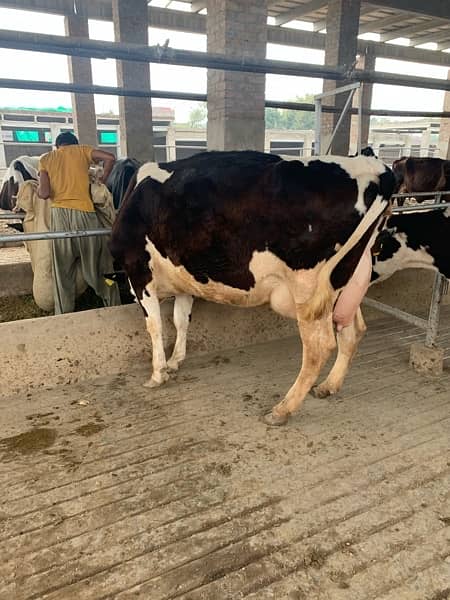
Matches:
[112,0,155,161]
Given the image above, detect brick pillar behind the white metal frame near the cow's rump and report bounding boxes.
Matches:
[321,0,361,155]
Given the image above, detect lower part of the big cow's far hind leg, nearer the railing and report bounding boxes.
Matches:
[311,308,367,398]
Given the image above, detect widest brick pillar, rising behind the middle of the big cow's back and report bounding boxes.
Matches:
[207,0,267,150]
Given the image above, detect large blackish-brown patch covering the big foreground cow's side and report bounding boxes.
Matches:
[111,152,394,293]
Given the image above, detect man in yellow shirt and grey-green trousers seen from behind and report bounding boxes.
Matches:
[38,132,120,314]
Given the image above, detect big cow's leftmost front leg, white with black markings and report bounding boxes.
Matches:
[141,284,169,387]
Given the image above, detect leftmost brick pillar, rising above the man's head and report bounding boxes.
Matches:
[63,14,98,146]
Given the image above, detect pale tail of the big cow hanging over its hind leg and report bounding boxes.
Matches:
[302,196,388,321]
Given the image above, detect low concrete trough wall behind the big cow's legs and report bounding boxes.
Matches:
[0,262,450,397]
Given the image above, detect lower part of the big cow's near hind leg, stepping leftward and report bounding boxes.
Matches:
[265,314,336,425]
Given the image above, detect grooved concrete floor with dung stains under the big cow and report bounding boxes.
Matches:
[0,310,450,600]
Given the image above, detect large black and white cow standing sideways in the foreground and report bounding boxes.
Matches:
[111,151,394,424]
